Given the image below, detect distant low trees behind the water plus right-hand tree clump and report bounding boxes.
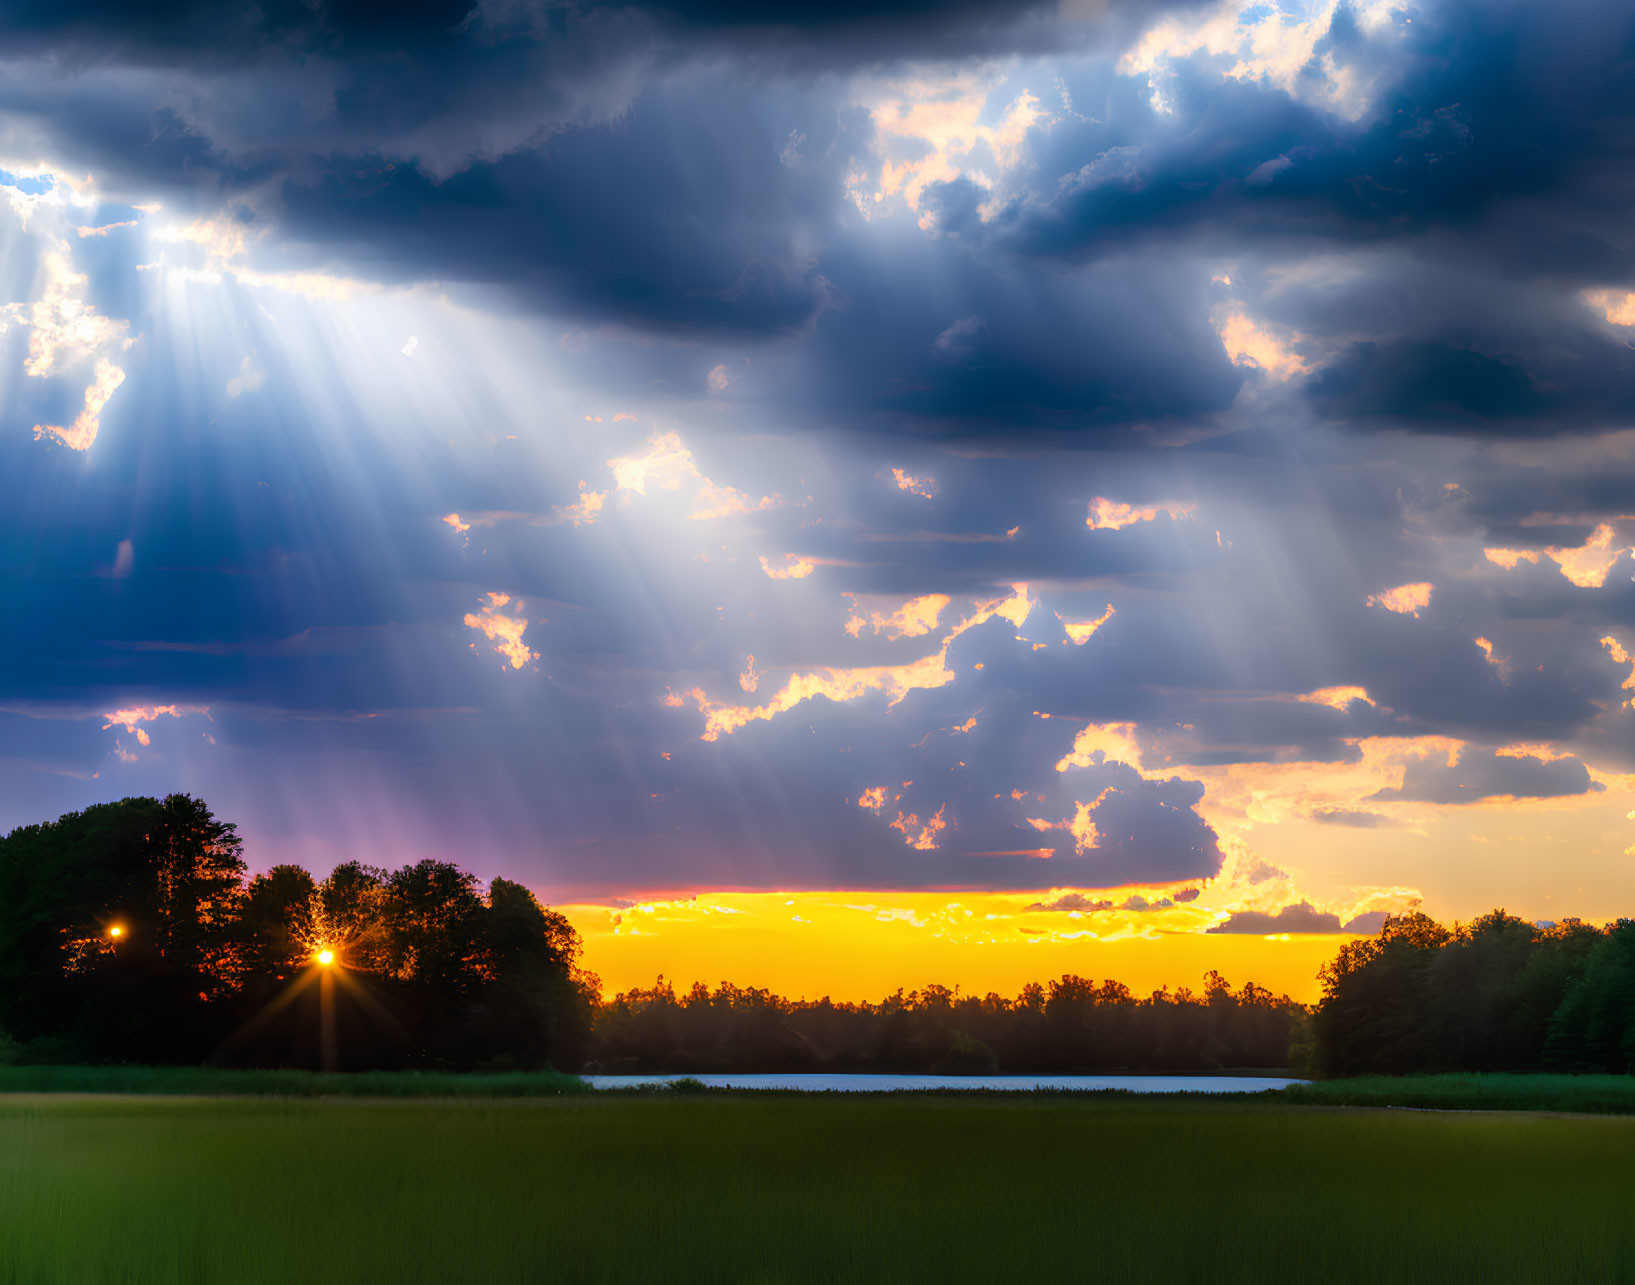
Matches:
[592,911,1635,1077]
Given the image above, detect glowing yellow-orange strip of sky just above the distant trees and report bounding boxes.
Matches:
[559,741,1635,1002]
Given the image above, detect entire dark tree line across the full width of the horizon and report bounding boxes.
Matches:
[0,795,1635,1076]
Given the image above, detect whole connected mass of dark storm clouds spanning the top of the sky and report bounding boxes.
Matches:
[0,3,1635,437]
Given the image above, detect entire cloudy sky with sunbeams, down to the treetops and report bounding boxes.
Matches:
[0,0,1635,999]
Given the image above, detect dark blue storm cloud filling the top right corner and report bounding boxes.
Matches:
[1024,0,1635,283]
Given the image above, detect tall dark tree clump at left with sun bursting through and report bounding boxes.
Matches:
[0,795,600,1069]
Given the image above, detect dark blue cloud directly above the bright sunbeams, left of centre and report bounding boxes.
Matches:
[269,82,837,337]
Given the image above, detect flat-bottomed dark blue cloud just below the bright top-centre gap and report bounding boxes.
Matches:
[784,237,1244,441]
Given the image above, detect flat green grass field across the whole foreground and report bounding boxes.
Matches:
[0,1094,1635,1285]
